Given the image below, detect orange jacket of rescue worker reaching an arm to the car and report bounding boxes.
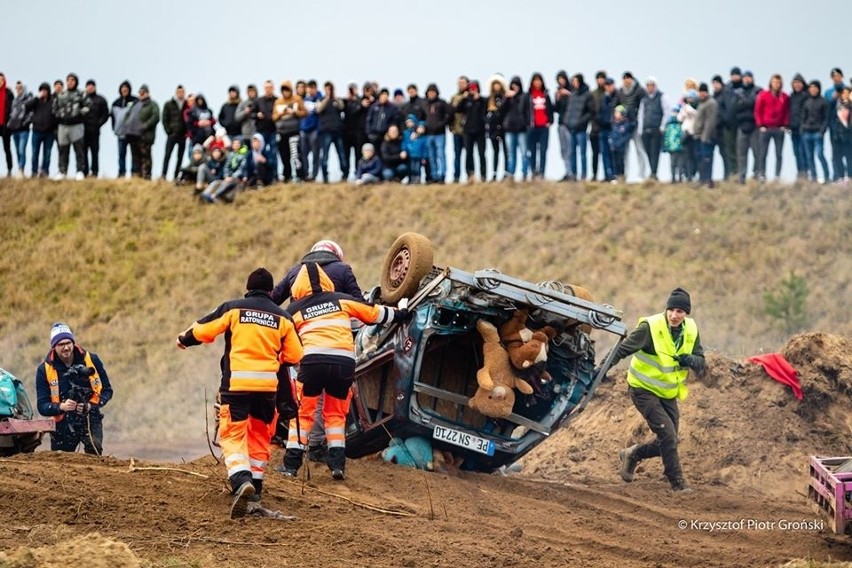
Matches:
[287,262,398,363]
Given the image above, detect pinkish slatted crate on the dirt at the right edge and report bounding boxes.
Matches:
[808,456,852,535]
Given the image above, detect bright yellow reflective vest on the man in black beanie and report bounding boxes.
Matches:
[627,312,698,400]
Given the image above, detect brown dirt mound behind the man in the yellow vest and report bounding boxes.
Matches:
[525,333,852,498]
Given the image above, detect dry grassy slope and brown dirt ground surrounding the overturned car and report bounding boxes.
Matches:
[0,176,852,568]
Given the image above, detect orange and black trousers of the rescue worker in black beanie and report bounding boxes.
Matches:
[219,392,277,485]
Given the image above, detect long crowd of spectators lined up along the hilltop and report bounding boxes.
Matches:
[0,67,852,194]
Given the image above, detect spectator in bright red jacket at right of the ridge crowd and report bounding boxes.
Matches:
[754,73,790,181]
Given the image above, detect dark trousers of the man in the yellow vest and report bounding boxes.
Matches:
[630,387,683,481]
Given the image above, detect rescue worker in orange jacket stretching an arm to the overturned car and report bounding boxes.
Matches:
[278,263,408,480]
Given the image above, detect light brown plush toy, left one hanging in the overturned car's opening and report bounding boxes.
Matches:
[469,319,533,418]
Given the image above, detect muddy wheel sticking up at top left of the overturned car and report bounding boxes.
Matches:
[381,233,434,305]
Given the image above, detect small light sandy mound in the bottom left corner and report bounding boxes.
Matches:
[0,533,141,568]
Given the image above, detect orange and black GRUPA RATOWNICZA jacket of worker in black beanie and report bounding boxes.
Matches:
[181,290,303,392]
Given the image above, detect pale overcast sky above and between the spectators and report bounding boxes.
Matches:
[5,0,852,178]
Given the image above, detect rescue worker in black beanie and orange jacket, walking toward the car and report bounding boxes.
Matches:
[177,268,303,518]
